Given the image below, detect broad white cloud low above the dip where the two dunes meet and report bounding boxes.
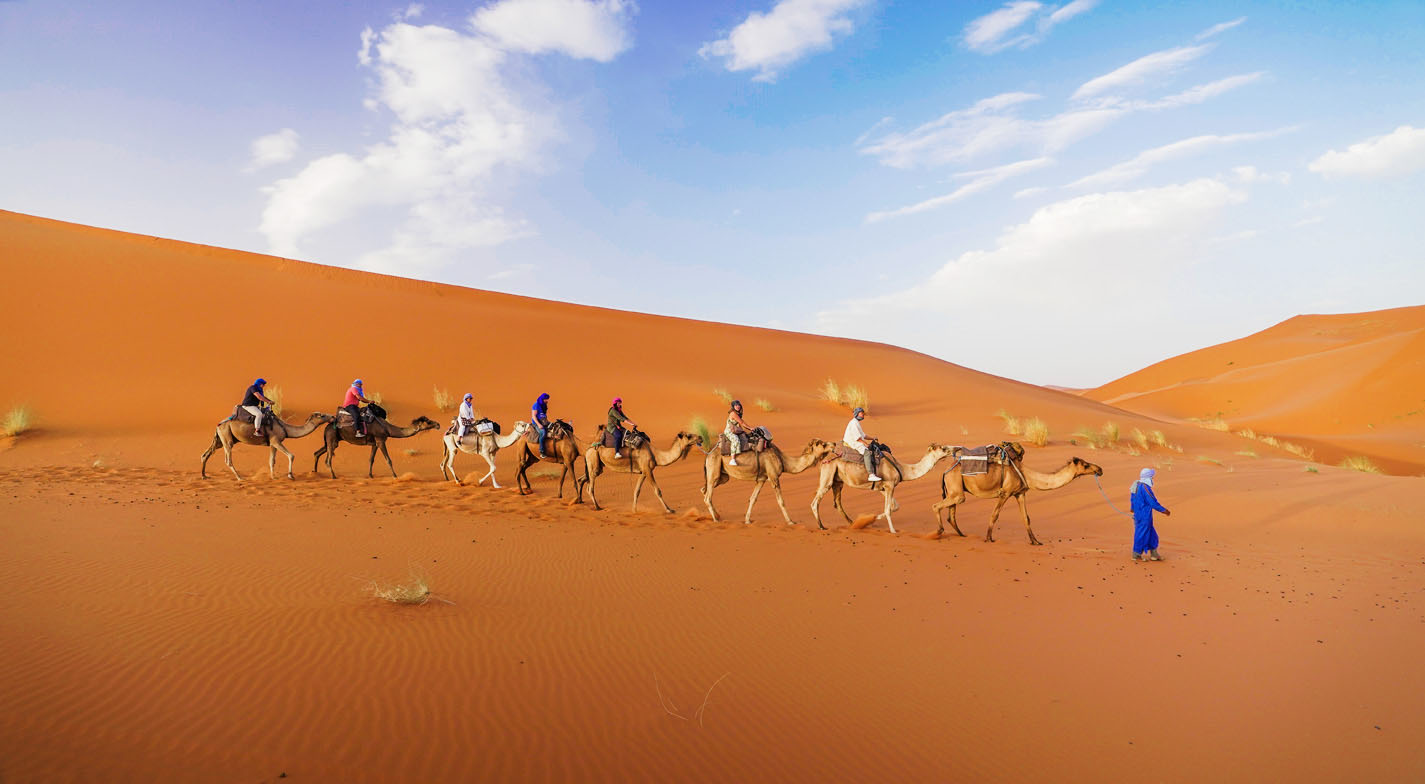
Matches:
[817,178,1247,385]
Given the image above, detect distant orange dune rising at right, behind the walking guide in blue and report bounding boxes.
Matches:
[1084,306,1425,475]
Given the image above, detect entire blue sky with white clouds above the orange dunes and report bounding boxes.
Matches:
[0,0,1425,386]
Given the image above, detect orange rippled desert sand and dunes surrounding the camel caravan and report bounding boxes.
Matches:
[0,212,1425,781]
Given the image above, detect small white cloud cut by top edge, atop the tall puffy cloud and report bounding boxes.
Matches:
[470,0,634,63]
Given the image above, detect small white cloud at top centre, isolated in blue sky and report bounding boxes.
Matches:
[698,0,868,81]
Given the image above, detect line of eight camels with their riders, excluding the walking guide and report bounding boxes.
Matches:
[200,378,1103,545]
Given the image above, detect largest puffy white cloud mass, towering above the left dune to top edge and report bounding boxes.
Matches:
[259,0,627,272]
